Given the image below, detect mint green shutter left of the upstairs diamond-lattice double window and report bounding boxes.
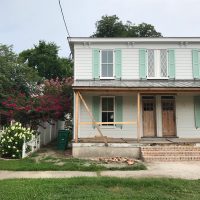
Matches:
[139,49,147,79]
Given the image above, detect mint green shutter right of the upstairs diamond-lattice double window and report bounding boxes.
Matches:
[168,49,176,79]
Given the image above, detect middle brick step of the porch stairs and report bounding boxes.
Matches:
[142,150,200,156]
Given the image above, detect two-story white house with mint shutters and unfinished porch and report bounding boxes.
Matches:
[69,37,200,159]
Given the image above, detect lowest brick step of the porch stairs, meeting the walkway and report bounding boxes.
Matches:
[143,156,200,162]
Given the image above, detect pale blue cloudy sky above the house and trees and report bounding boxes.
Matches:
[0,0,200,56]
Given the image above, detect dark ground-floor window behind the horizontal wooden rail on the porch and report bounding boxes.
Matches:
[101,97,115,126]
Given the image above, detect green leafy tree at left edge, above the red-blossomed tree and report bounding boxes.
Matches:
[0,44,39,98]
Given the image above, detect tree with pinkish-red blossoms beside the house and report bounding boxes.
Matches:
[0,78,73,125]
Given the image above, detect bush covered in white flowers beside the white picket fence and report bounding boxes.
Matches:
[0,122,34,158]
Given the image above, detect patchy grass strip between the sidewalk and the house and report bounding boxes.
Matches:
[0,155,146,171]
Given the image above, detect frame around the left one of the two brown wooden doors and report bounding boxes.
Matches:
[141,95,157,138]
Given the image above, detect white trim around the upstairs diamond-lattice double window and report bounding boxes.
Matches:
[146,49,169,80]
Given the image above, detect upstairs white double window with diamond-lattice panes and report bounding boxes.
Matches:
[147,49,168,78]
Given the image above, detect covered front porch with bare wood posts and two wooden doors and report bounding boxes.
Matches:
[74,80,200,144]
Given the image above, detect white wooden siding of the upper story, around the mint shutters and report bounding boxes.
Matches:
[74,43,200,80]
